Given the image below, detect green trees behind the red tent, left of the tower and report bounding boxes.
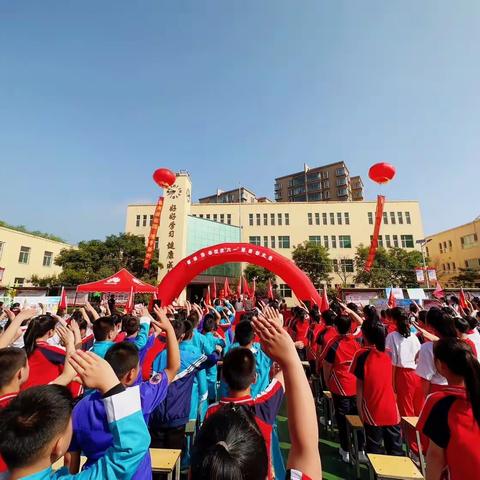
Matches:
[51,233,158,285]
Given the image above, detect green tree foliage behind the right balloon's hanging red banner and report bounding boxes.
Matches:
[355,246,422,288]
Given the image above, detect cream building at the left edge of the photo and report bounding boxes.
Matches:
[0,227,72,286]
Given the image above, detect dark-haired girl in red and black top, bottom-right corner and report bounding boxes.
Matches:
[417,338,480,480]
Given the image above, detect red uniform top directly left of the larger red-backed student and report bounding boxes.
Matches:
[320,335,360,397]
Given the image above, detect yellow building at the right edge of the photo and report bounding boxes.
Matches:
[426,218,480,287]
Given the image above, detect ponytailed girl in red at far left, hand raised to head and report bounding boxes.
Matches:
[22,315,66,389]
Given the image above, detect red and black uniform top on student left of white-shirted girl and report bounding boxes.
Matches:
[350,347,400,427]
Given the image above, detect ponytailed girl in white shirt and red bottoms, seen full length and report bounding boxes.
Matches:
[386,307,425,417]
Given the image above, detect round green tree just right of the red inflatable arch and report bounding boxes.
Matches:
[292,241,332,288]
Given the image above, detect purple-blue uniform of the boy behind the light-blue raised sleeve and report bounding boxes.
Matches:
[69,372,168,480]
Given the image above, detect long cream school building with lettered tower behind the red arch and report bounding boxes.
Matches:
[125,172,424,298]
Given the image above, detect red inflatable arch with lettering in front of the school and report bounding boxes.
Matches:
[158,243,321,305]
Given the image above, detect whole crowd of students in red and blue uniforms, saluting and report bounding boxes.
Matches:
[0,290,480,480]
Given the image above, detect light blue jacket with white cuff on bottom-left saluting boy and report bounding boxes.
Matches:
[23,387,150,480]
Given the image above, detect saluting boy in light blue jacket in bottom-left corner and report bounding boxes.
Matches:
[0,351,150,480]
